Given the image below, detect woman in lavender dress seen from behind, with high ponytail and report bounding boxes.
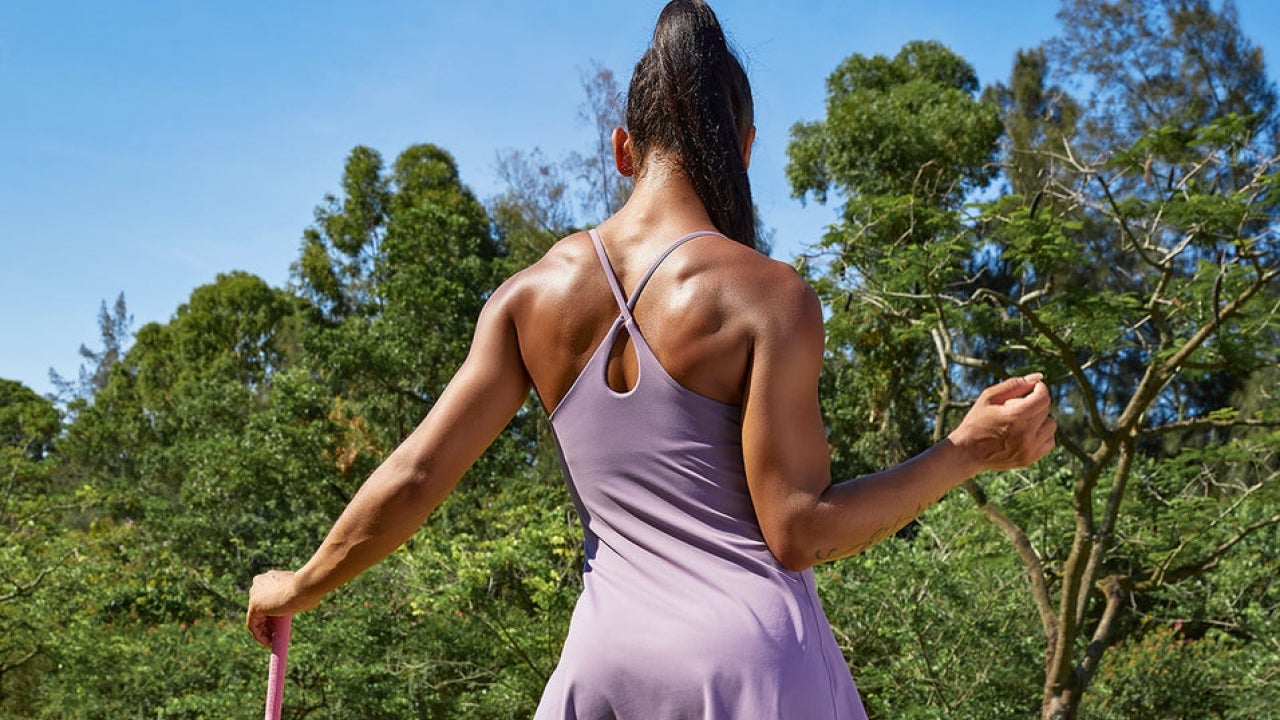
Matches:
[248,0,1055,720]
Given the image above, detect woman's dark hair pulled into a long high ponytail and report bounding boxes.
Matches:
[627,0,755,247]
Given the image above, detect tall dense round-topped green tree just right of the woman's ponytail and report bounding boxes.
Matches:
[787,42,1000,477]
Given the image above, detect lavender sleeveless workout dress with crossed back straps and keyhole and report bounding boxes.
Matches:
[535,231,867,720]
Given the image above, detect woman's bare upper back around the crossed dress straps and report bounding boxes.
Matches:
[501,223,801,413]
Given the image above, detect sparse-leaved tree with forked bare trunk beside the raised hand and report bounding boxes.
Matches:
[788,3,1280,719]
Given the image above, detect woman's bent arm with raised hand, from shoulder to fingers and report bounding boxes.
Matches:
[742,266,1057,570]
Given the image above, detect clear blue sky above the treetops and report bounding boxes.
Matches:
[0,0,1280,393]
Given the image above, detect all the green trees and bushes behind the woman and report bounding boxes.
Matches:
[10,9,1280,719]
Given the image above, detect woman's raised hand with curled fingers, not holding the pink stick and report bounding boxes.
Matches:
[948,373,1057,474]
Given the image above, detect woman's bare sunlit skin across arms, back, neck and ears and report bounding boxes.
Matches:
[247,128,1056,646]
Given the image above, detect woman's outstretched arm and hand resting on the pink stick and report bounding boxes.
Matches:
[246,281,530,646]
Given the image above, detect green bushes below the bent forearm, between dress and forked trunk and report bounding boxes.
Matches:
[817,489,1043,720]
